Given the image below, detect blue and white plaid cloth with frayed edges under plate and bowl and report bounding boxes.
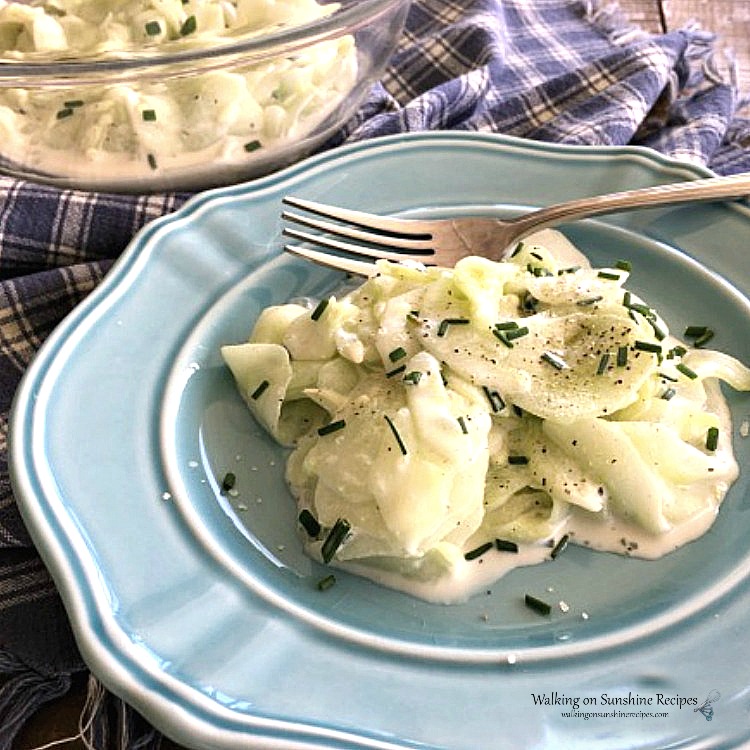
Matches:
[0,0,750,750]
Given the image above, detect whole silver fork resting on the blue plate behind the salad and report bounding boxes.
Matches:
[281,173,750,276]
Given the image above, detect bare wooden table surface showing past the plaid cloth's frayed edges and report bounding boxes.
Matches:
[13,0,750,750]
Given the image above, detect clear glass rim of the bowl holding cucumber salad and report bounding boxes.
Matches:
[0,0,410,82]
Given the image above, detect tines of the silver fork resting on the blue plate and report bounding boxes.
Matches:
[281,196,435,267]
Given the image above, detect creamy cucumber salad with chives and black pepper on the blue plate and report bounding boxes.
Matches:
[222,230,750,603]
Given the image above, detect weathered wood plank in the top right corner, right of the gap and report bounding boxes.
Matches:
[661,0,750,94]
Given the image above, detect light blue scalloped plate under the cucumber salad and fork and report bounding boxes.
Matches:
[11,133,750,750]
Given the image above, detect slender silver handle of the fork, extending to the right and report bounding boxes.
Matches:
[514,173,750,236]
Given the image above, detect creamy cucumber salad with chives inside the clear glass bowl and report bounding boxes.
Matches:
[0,0,357,184]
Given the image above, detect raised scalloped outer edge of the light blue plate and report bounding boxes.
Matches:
[9,133,750,748]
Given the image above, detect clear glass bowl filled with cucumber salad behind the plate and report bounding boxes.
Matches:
[0,0,409,192]
